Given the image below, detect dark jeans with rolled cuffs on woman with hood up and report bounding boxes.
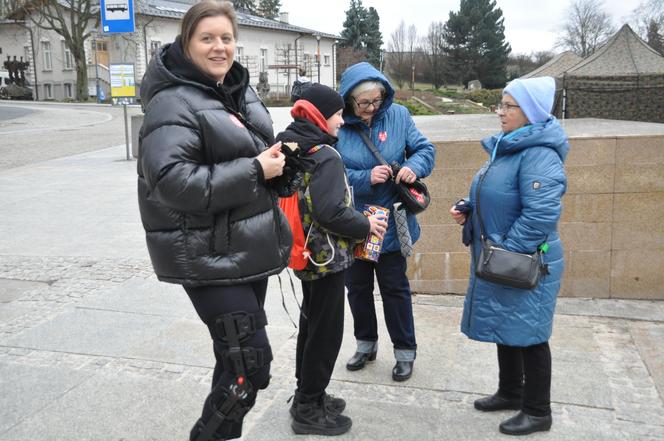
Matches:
[346,251,417,350]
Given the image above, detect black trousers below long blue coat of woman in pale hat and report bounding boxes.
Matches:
[498,342,551,416]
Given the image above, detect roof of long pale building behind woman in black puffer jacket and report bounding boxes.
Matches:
[137,0,339,39]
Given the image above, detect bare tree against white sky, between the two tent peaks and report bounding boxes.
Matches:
[557,0,615,57]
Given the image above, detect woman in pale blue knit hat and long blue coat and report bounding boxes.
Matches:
[450,77,569,435]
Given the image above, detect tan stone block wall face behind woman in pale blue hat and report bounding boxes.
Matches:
[409,136,664,300]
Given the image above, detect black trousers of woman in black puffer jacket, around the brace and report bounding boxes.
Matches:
[184,279,270,439]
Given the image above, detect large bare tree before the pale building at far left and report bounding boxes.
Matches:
[10,0,100,101]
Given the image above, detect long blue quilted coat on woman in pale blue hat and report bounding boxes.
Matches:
[461,117,569,347]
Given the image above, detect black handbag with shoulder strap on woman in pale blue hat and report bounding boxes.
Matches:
[475,166,548,290]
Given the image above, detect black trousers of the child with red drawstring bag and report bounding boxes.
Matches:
[295,271,344,401]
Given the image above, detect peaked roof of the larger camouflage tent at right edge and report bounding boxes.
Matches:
[567,25,664,76]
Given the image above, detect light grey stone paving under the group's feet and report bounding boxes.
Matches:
[0,104,664,441]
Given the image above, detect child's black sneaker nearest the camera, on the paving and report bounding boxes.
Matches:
[291,398,353,436]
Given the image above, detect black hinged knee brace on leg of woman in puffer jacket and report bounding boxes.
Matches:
[191,310,272,441]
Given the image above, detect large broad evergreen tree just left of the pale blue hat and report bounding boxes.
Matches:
[444,0,512,88]
